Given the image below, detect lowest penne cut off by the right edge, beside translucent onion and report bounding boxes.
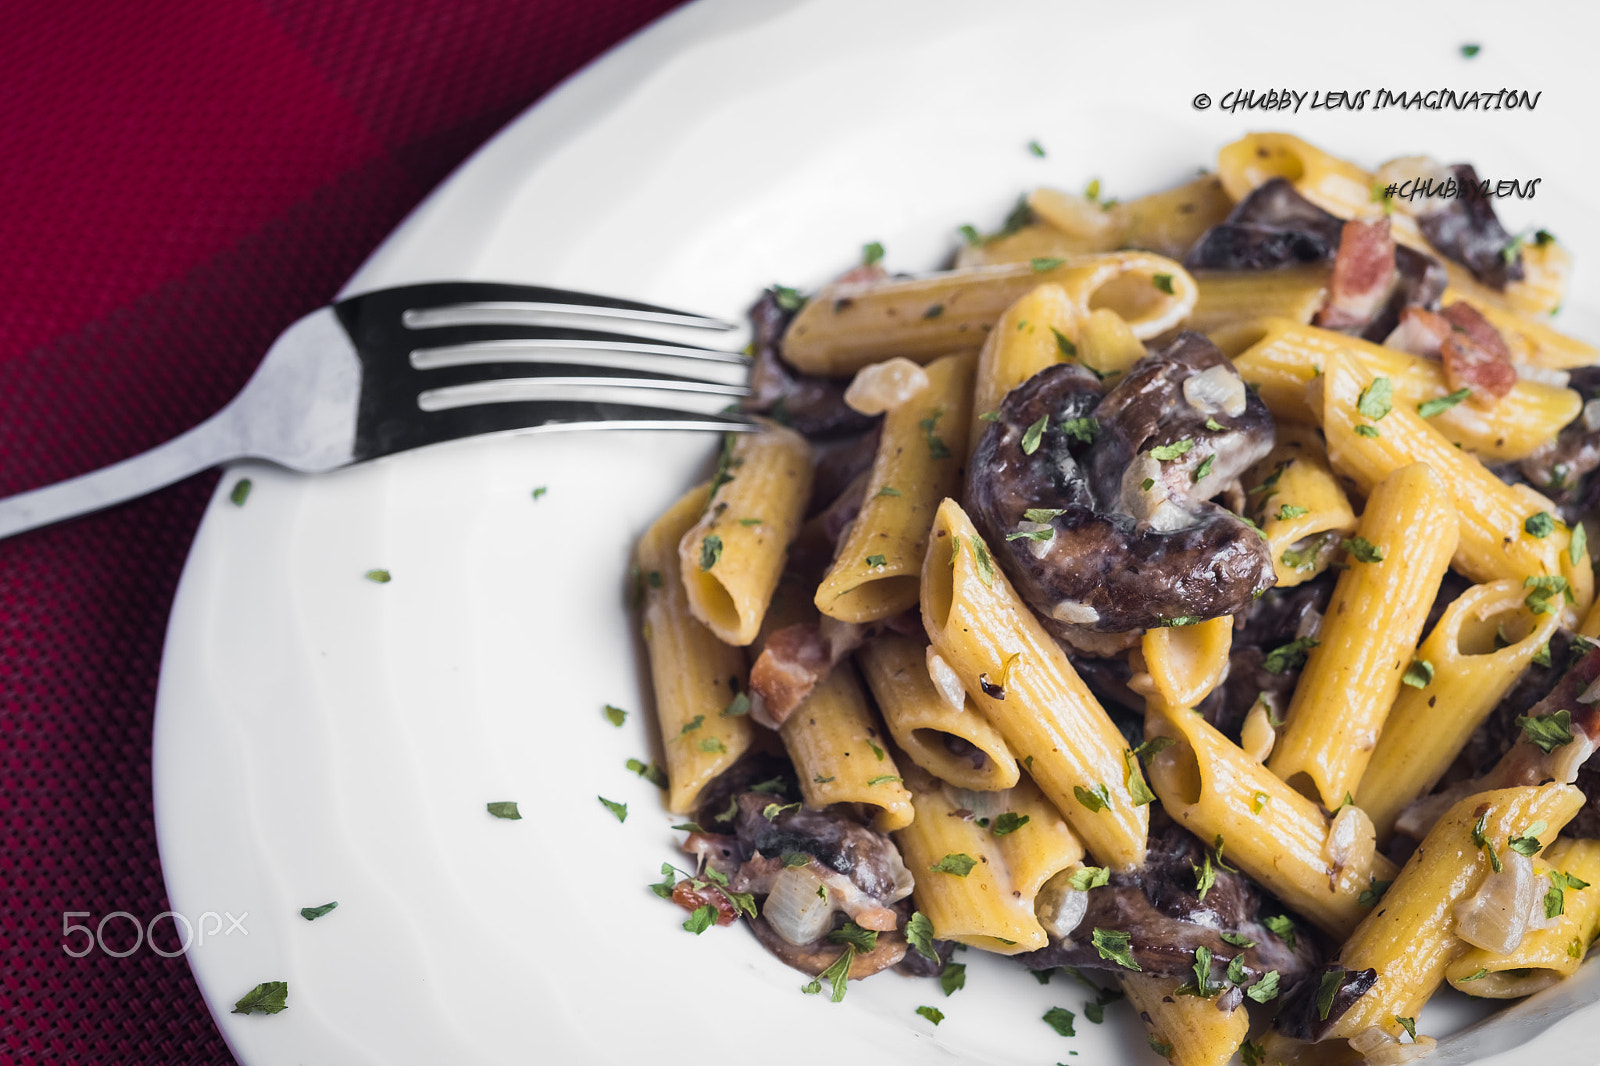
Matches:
[1445,837,1600,999]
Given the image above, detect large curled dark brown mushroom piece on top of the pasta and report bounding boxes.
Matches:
[968,333,1274,639]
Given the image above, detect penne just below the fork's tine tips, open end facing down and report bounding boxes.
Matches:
[678,424,811,647]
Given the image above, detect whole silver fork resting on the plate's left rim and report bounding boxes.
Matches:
[0,282,755,538]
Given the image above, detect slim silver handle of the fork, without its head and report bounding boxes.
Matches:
[0,408,242,539]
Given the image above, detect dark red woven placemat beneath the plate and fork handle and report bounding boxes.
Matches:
[0,0,678,1064]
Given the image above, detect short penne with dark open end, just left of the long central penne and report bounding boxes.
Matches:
[856,634,1018,791]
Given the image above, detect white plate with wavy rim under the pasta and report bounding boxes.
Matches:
[155,0,1600,1066]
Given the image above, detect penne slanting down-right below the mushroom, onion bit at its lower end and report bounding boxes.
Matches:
[1144,709,1395,936]
